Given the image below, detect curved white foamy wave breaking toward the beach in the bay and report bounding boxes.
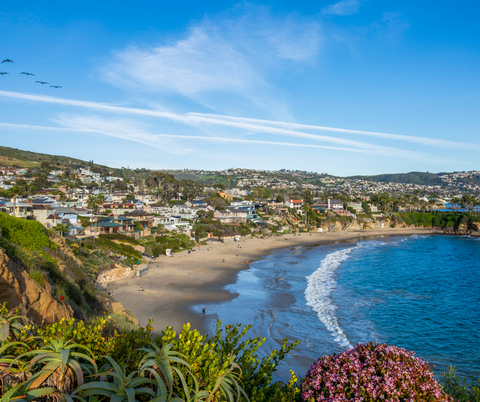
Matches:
[305,248,353,348]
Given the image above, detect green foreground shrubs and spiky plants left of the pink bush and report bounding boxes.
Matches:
[0,304,300,402]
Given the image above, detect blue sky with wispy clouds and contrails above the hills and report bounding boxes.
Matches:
[0,0,480,176]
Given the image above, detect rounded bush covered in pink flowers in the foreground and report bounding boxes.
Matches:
[302,343,453,402]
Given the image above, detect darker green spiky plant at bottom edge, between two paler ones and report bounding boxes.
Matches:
[74,356,158,402]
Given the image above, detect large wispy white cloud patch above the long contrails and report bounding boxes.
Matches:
[100,6,320,115]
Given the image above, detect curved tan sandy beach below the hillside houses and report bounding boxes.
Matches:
[108,228,431,334]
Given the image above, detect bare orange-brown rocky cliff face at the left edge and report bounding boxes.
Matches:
[0,248,72,324]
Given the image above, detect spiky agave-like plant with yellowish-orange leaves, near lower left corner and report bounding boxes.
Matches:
[15,339,97,393]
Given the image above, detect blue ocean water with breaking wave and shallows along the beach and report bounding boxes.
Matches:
[201,236,480,380]
